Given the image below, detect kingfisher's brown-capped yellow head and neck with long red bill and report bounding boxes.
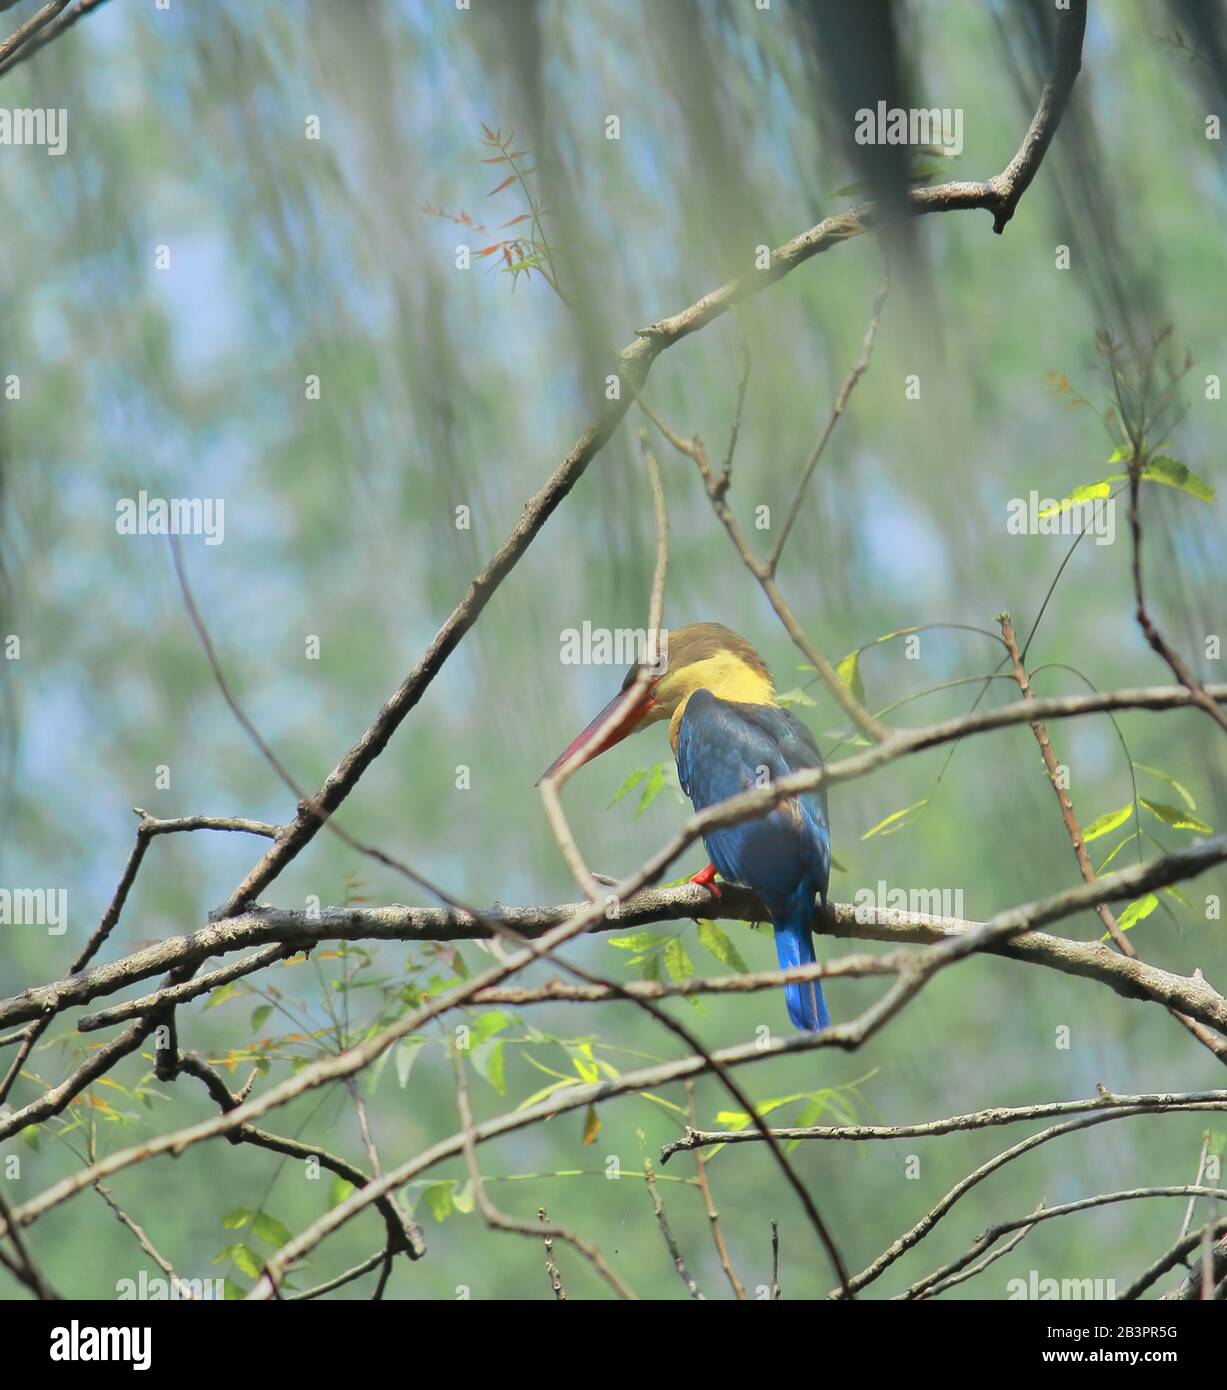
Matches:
[539,623,775,781]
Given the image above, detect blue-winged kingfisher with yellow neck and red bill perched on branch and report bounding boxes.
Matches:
[542,623,831,1030]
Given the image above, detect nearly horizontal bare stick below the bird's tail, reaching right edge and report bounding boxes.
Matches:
[660,1087,1227,1177]
